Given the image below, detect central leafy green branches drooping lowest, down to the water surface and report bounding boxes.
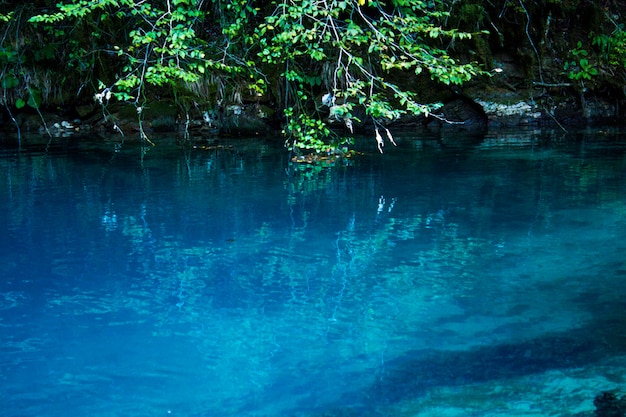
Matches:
[254,0,481,153]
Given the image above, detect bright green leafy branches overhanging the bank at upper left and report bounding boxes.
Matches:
[30,0,251,139]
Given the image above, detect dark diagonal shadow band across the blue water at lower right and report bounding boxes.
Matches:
[311,303,626,417]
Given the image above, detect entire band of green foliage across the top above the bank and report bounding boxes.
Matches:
[7,0,626,154]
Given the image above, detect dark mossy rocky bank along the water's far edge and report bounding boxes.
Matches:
[2,78,624,137]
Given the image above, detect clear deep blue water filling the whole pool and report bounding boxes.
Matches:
[0,131,626,417]
